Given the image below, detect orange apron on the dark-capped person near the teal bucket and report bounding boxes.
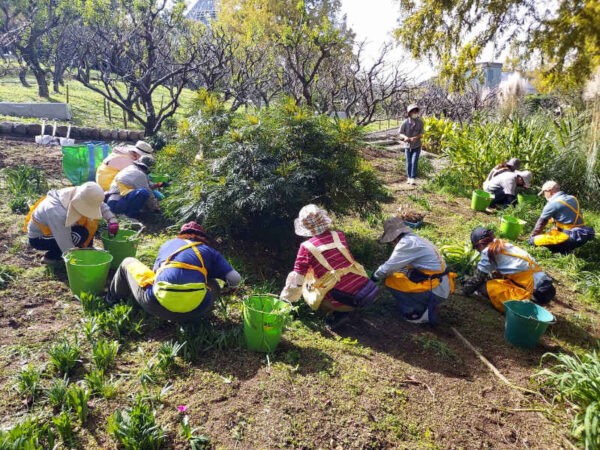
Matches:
[486,252,542,313]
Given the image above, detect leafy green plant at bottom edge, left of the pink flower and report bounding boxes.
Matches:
[108,396,165,450]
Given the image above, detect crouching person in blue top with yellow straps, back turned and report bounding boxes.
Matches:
[106,222,241,322]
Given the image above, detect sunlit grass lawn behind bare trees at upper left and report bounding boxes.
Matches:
[0,77,193,129]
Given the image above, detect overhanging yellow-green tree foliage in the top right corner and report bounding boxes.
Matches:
[396,0,600,89]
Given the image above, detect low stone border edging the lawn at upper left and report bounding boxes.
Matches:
[0,122,144,142]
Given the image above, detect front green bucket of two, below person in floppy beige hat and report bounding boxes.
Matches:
[63,248,113,296]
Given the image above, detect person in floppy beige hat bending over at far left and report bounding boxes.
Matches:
[24,182,119,264]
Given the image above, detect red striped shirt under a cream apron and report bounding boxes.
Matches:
[294,231,368,294]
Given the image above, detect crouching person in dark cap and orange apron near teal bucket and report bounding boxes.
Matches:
[462,227,556,313]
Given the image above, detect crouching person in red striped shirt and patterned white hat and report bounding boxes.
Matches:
[280,205,378,329]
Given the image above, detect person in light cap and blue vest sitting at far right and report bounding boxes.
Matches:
[529,181,596,253]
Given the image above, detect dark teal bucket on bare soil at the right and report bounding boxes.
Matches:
[504,300,556,348]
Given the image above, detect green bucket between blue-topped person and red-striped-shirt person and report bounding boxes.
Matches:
[244,294,291,352]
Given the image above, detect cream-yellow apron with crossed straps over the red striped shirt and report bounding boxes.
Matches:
[302,231,368,311]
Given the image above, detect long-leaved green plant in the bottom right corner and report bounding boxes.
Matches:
[538,351,600,449]
